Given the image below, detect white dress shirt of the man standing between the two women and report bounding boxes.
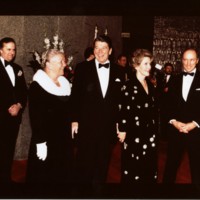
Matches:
[95,59,110,97]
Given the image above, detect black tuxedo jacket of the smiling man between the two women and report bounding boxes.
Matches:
[71,60,125,142]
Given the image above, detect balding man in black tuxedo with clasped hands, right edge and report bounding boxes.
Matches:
[163,49,200,184]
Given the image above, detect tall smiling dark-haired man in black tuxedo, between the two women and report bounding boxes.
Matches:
[71,35,125,193]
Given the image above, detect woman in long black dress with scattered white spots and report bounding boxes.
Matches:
[118,49,158,184]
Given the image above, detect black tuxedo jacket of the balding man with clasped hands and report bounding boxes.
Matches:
[168,71,200,132]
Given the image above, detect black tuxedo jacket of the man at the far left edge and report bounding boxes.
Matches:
[0,60,27,122]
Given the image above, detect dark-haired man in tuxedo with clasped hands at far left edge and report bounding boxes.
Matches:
[0,37,27,183]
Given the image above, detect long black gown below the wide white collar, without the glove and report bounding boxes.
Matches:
[27,72,73,184]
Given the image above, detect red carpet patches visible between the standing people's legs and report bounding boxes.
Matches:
[12,141,191,183]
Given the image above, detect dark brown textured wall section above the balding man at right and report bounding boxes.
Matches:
[153,16,200,72]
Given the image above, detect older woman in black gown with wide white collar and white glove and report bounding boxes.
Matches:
[27,49,73,183]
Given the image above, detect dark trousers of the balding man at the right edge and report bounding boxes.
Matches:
[163,127,200,184]
